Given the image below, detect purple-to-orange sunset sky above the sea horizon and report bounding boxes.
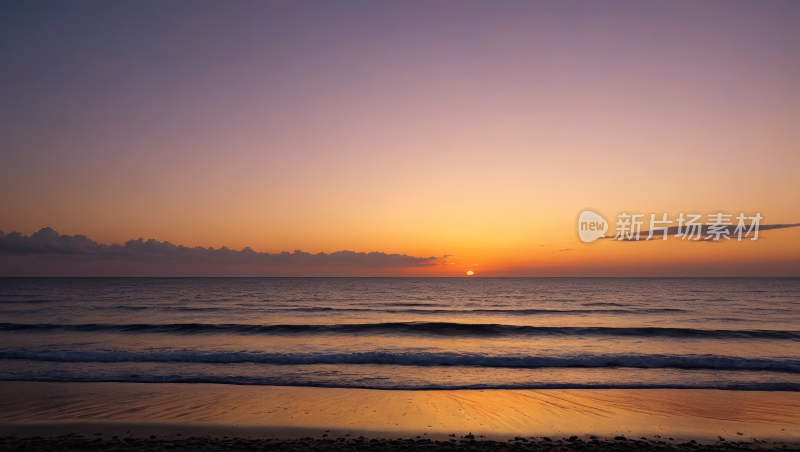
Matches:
[0,0,800,277]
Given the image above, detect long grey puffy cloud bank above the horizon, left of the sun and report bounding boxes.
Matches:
[0,228,447,268]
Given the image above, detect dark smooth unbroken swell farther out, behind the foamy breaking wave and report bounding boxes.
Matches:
[0,322,800,341]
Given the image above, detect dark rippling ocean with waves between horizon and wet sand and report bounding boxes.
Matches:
[0,278,800,391]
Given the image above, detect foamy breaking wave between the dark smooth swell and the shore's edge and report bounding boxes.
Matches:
[0,350,800,373]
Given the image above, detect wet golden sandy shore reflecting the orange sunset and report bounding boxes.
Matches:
[0,382,800,447]
